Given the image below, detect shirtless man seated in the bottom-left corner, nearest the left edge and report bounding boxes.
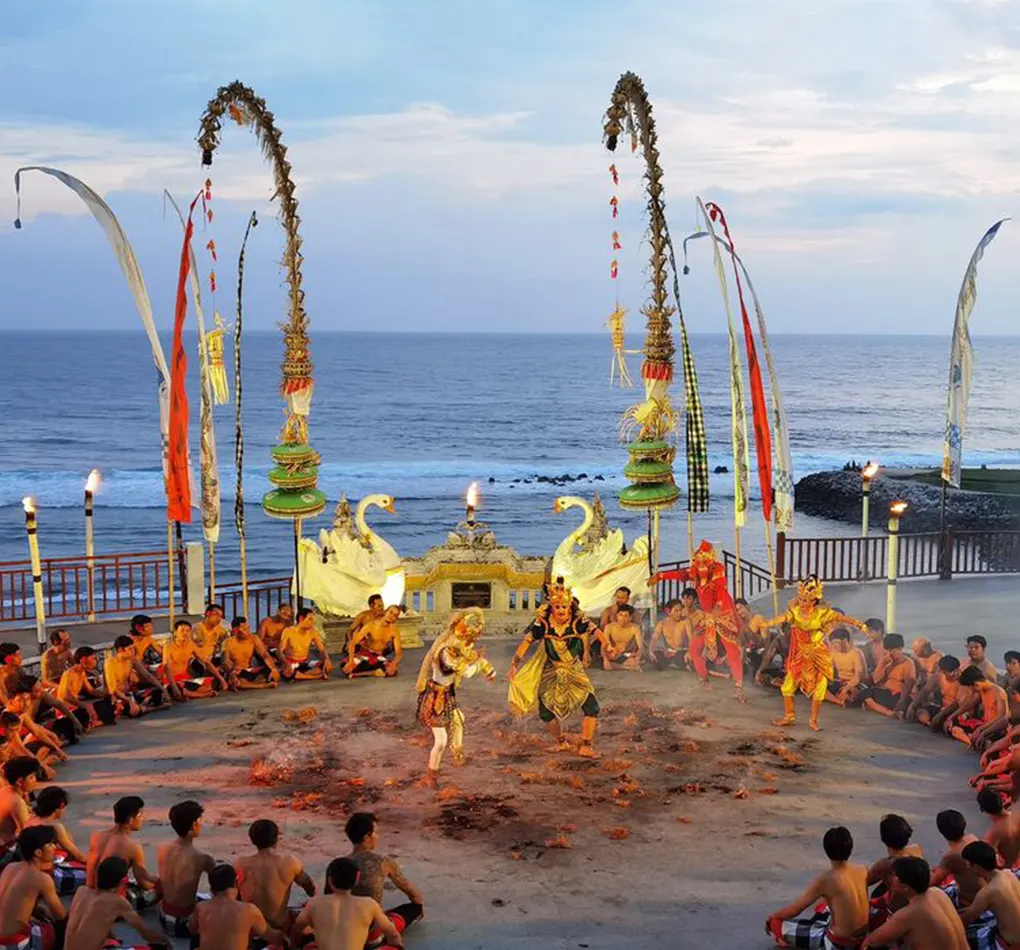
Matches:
[0,827,67,950]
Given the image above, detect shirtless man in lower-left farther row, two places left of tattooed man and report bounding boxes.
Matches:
[156,801,216,938]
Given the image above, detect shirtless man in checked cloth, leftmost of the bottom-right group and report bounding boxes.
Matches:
[765,828,868,950]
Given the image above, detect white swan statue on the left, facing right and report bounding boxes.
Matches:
[298,495,405,616]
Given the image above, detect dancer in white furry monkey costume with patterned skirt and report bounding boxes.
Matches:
[416,607,496,784]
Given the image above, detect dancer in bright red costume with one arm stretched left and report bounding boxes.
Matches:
[648,541,744,702]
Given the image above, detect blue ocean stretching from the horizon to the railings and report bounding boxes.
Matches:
[0,327,1020,583]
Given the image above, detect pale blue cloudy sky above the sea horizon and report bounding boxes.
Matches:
[0,0,1020,335]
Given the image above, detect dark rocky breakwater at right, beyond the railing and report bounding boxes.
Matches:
[795,471,1020,534]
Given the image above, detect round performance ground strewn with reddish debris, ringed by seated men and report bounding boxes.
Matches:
[58,643,979,950]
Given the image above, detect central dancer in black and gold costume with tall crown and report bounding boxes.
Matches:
[508,579,600,758]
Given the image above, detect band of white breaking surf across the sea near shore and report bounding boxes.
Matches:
[0,450,1020,509]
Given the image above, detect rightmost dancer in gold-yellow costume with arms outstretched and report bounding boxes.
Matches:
[765,574,864,732]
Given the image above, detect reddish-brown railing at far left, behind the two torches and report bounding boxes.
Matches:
[0,551,181,624]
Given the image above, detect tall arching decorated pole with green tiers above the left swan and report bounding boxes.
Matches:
[198,82,325,587]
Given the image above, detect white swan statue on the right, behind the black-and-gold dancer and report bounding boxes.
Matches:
[552,494,653,616]
